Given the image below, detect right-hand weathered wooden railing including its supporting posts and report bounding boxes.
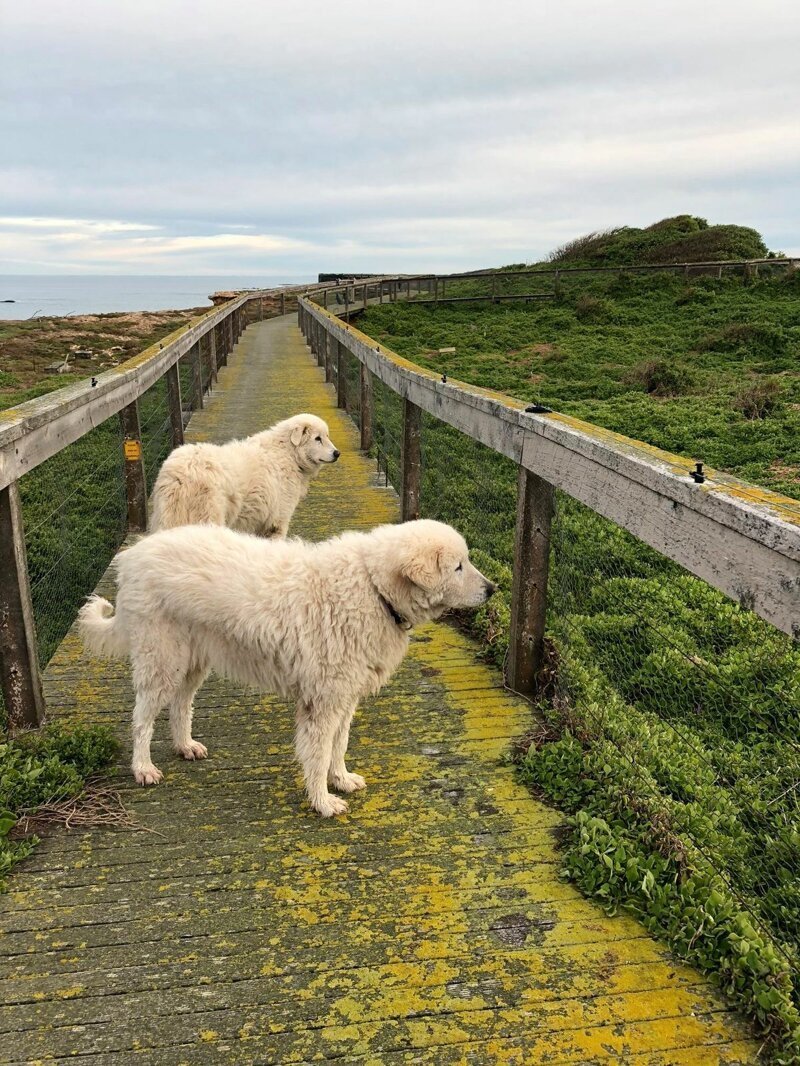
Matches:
[299,287,800,693]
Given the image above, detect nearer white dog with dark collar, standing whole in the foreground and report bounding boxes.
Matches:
[79,519,495,817]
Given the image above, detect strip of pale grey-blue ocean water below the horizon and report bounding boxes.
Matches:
[0,274,316,320]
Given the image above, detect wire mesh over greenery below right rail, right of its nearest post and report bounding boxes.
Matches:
[548,494,800,967]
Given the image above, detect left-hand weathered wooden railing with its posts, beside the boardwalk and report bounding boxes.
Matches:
[0,286,326,729]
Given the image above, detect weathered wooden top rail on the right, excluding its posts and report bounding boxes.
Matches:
[308,304,800,636]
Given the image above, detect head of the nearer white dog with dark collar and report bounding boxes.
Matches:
[381,518,496,623]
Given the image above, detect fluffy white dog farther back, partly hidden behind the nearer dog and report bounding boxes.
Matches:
[150,415,339,537]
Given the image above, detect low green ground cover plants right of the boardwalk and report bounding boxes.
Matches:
[358,227,800,1063]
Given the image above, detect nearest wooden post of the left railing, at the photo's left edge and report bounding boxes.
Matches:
[0,482,45,732]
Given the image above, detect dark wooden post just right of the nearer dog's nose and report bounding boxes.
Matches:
[508,467,556,695]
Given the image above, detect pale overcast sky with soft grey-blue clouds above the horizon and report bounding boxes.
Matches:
[0,0,800,275]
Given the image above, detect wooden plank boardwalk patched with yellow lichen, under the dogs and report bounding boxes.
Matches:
[0,318,757,1066]
